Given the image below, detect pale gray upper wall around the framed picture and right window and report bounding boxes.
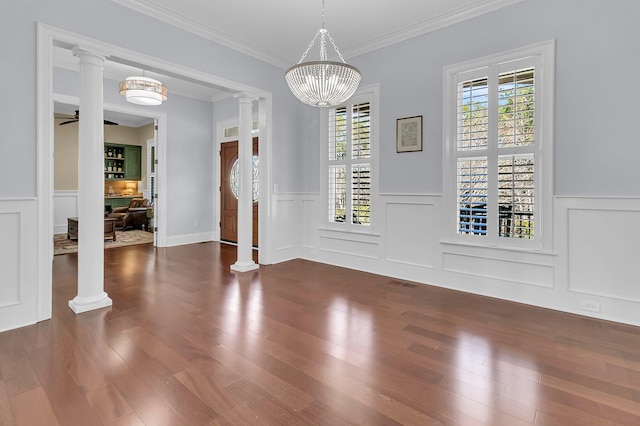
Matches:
[302,0,640,196]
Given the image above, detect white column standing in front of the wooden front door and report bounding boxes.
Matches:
[231,94,258,272]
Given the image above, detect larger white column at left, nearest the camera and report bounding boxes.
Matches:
[69,47,112,314]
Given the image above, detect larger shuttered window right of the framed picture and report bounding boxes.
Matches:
[445,43,553,248]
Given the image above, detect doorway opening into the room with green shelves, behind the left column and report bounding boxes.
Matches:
[52,95,158,256]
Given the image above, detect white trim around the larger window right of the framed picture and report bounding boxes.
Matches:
[442,40,555,251]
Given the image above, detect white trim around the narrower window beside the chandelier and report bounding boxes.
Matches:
[319,84,380,234]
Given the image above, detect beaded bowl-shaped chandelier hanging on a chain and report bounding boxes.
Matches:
[285,0,361,107]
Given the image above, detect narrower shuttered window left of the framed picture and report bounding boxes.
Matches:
[325,88,375,230]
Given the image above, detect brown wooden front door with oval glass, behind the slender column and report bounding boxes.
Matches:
[220,138,258,247]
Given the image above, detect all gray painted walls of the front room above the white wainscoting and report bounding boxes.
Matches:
[0,0,640,218]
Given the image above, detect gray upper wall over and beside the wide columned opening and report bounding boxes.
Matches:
[0,0,299,198]
